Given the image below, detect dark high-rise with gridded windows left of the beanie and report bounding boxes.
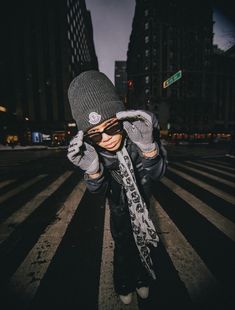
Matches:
[0,0,98,145]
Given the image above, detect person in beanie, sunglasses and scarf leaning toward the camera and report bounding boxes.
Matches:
[67,70,167,304]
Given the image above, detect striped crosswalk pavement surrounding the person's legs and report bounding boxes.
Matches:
[0,156,235,310]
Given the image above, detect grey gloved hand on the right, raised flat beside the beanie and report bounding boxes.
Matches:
[116,110,157,153]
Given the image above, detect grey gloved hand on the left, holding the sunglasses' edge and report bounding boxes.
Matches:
[67,131,100,174]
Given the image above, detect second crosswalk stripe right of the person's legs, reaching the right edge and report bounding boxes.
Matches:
[161,177,235,241]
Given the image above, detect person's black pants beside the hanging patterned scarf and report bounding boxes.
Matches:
[109,180,149,295]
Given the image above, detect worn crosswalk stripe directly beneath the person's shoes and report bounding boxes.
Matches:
[98,201,139,310]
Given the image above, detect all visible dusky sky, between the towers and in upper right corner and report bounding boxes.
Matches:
[85,0,235,81]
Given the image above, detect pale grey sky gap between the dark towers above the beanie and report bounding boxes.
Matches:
[86,0,135,81]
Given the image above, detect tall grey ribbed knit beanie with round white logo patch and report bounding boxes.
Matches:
[68,70,125,132]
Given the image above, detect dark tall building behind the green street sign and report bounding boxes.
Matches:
[127,0,230,132]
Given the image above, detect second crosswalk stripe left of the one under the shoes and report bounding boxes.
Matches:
[0,171,72,245]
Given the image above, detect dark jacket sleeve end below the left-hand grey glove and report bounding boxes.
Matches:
[84,165,109,194]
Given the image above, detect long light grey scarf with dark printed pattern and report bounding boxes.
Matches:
[117,146,159,279]
